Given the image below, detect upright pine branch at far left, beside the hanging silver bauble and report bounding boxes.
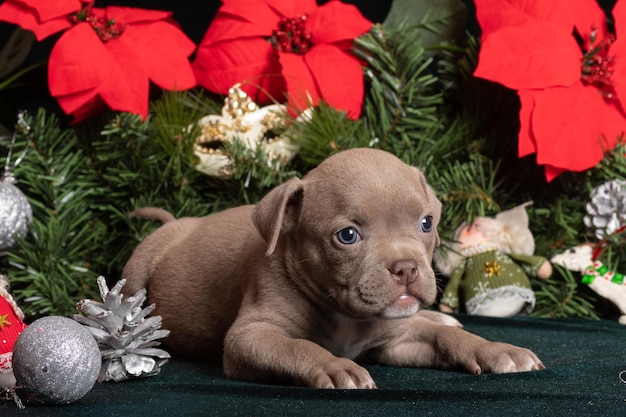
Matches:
[8,111,102,315]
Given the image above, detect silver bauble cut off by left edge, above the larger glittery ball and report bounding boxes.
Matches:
[0,180,33,250]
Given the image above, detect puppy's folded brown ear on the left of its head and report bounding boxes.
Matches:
[252,178,303,255]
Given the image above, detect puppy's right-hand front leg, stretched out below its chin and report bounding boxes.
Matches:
[370,318,544,375]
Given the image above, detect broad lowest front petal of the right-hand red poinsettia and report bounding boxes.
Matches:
[532,83,626,171]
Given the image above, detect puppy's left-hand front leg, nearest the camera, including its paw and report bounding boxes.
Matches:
[224,323,376,389]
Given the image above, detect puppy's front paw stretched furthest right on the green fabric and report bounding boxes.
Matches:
[467,342,545,375]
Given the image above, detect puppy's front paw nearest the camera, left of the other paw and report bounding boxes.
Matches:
[306,358,376,389]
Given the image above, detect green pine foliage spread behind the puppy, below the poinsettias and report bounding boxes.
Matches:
[0,17,626,318]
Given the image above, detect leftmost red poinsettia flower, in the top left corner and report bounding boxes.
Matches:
[0,0,196,122]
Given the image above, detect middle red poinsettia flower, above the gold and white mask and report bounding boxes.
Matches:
[192,0,372,118]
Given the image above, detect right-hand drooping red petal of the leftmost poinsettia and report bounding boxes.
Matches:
[118,21,196,90]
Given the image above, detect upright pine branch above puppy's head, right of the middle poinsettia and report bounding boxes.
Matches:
[354,25,443,161]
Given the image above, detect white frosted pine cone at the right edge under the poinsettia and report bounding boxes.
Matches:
[584,180,626,240]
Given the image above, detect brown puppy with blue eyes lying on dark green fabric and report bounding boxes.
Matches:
[123,149,543,388]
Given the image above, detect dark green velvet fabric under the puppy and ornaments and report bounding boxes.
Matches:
[0,316,626,417]
